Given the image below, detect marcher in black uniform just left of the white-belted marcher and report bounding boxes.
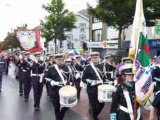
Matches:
[20,52,31,102]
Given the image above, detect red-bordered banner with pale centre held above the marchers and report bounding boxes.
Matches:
[16,30,42,53]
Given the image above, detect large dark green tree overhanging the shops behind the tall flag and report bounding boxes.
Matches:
[88,0,160,49]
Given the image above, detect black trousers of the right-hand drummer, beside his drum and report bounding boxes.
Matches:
[87,86,105,120]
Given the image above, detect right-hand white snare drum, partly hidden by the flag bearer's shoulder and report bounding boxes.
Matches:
[98,84,114,102]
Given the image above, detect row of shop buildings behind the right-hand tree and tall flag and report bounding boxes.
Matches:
[88,15,160,58]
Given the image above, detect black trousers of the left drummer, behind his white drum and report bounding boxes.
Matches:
[52,86,69,120]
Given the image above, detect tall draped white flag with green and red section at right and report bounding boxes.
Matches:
[129,0,153,105]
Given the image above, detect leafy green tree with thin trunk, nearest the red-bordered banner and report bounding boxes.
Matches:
[41,0,76,53]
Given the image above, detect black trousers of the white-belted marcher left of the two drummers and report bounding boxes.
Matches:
[31,76,43,108]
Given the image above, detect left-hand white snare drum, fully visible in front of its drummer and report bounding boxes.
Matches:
[59,85,77,107]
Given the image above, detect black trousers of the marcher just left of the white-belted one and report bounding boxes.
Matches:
[22,72,31,99]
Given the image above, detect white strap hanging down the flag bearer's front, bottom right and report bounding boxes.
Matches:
[123,90,134,120]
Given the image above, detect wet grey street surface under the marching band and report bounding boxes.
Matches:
[0,64,148,120]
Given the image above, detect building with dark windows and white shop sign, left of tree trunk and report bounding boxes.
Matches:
[88,15,118,57]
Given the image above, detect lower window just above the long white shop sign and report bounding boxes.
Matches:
[92,29,102,41]
